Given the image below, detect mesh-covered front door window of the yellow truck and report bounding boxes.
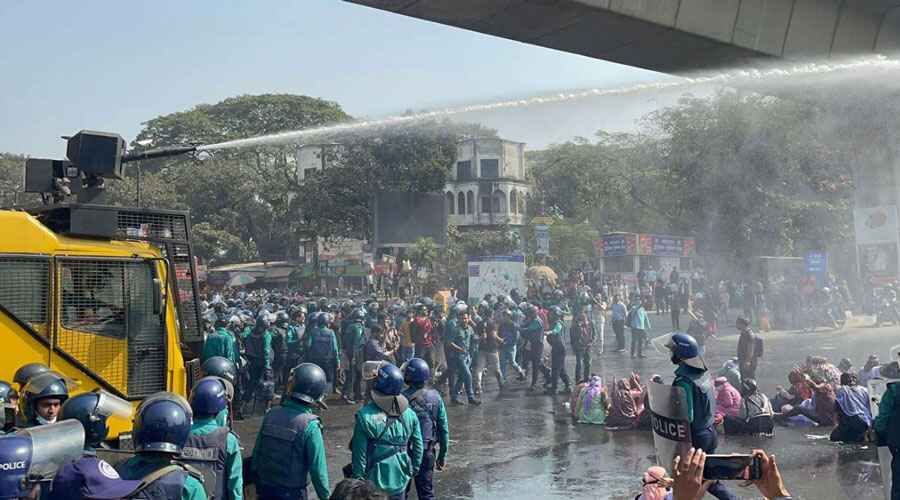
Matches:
[60,259,155,338]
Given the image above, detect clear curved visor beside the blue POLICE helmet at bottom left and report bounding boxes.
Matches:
[16,419,84,478]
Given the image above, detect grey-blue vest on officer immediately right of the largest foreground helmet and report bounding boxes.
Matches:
[179,427,230,500]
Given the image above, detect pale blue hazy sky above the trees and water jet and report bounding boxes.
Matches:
[0,0,676,157]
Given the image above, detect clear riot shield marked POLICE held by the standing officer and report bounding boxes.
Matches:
[647,382,691,469]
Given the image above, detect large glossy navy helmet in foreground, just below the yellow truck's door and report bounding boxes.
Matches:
[132,392,193,455]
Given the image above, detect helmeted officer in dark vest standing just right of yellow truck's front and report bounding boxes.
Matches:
[242,310,275,413]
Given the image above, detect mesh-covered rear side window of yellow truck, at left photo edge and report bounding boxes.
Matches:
[0,255,50,337]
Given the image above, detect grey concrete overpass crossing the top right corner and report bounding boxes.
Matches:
[345,0,900,73]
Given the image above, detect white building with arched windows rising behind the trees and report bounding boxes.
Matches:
[444,139,531,230]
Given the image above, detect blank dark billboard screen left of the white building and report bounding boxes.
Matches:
[372,191,447,247]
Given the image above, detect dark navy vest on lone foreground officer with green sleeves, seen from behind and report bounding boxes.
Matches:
[253,406,319,490]
